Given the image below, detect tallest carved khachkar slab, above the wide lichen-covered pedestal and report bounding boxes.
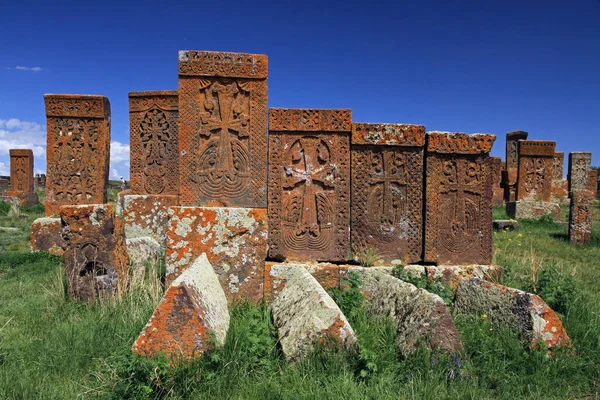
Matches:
[179,51,268,208]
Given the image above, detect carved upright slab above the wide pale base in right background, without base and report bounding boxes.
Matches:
[517,140,556,202]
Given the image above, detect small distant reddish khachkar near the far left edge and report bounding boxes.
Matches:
[7,149,38,206]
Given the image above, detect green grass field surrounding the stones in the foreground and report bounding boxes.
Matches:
[0,202,600,400]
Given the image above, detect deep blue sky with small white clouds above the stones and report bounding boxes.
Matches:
[0,0,600,177]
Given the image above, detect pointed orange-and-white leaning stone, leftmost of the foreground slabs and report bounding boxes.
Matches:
[131,254,229,359]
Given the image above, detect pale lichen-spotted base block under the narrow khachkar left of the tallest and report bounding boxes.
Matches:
[123,194,179,248]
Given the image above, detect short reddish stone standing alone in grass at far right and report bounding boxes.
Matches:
[569,186,596,245]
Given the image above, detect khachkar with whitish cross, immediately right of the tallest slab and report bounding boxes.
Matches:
[268,108,352,261]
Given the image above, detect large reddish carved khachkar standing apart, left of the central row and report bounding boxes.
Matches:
[44,94,110,216]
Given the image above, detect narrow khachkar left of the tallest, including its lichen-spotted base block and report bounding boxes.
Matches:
[123,90,179,246]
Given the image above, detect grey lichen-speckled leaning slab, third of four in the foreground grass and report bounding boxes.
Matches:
[351,267,462,356]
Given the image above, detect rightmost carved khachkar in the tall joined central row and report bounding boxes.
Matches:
[424,132,496,265]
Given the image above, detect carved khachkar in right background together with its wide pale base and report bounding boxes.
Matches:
[506,140,560,219]
